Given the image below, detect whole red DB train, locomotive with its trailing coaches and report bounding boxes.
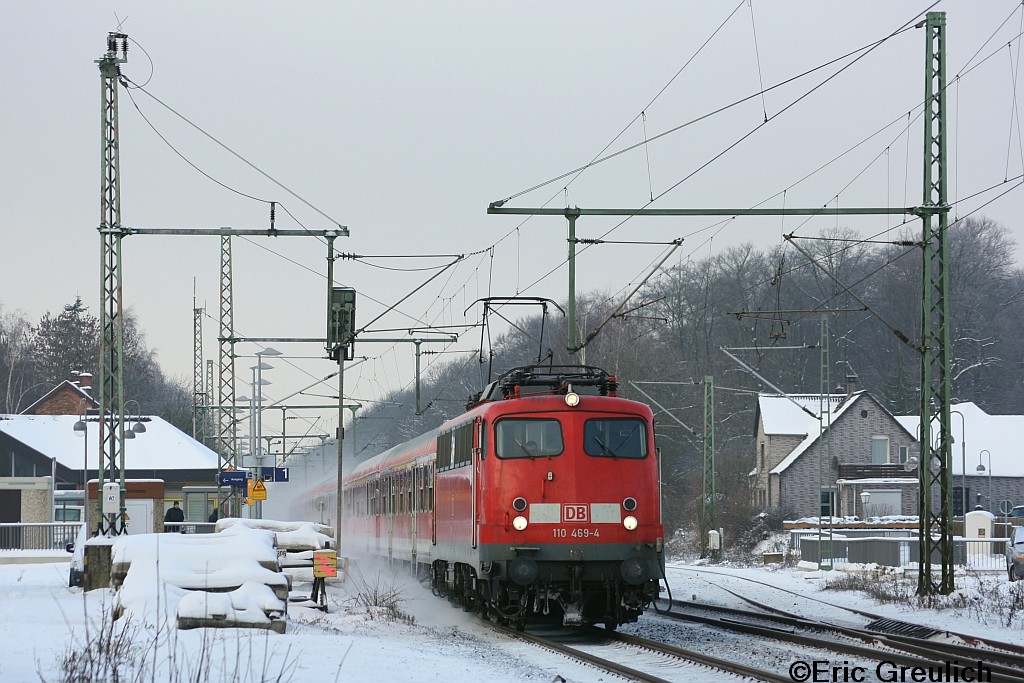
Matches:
[343,366,665,628]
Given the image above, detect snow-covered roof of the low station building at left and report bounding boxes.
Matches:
[0,415,217,470]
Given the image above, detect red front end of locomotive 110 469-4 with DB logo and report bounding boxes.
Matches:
[474,368,664,628]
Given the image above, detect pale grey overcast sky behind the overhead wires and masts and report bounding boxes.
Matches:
[0,0,1024,444]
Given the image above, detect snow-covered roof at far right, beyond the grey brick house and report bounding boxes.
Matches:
[896,401,1024,477]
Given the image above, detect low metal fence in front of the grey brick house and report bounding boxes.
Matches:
[793,533,1010,570]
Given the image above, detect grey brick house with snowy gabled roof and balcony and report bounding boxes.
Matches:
[750,391,919,518]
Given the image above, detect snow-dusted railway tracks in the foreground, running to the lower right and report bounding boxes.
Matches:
[487,589,1024,683]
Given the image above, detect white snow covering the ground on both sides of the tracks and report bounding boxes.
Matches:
[0,548,1024,683]
